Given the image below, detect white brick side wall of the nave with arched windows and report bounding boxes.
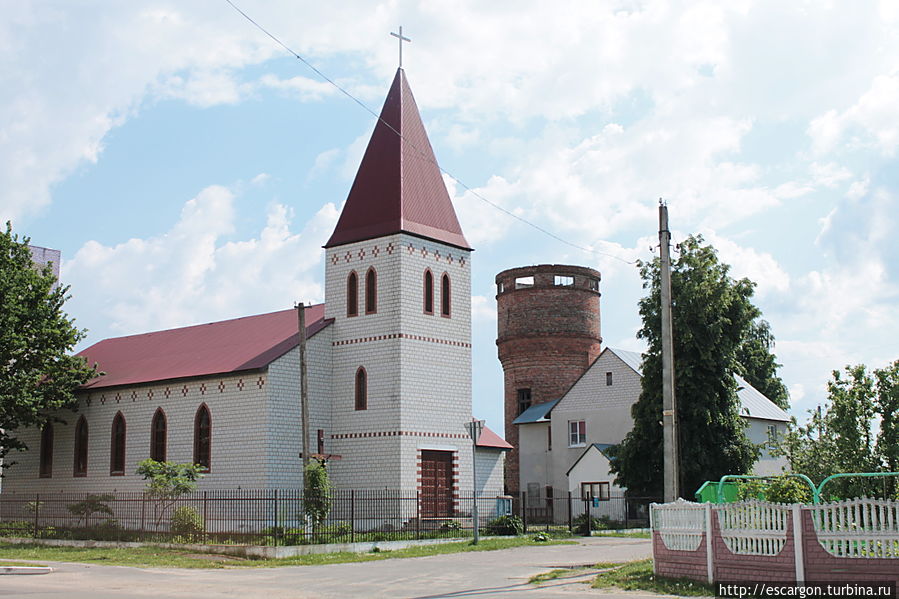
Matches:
[3,371,269,494]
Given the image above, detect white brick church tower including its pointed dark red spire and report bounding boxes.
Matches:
[325,68,471,500]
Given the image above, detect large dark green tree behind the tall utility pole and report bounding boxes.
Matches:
[612,236,783,497]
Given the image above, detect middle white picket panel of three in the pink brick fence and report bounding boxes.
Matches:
[713,501,792,555]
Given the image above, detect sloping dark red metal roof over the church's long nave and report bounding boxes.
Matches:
[78,304,332,389]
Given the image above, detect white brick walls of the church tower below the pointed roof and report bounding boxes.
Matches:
[325,234,472,492]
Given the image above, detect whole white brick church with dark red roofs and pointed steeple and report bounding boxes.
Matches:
[3,69,511,501]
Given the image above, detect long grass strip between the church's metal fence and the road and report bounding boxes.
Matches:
[0,537,573,568]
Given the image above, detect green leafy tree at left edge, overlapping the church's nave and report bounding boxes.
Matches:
[0,222,97,467]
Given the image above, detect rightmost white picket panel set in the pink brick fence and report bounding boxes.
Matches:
[804,499,899,559]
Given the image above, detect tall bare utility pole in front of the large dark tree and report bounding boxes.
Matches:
[659,199,680,502]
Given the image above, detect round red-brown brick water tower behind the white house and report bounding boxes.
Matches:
[496,264,602,492]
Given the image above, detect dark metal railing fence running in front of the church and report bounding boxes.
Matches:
[0,489,652,545]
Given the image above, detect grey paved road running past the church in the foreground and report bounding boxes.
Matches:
[0,537,652,599]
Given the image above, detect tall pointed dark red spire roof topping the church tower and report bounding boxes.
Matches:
[325,69,471,250]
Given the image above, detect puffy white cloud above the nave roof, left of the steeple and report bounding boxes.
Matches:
[63,185,337,341]
